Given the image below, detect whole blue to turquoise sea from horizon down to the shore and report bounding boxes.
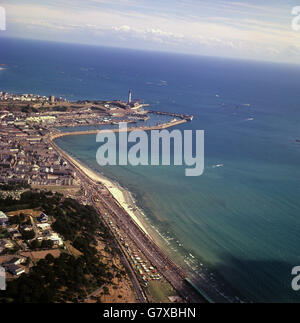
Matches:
[0,38,300,302]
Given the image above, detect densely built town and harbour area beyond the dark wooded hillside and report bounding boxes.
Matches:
[0,92,191,186]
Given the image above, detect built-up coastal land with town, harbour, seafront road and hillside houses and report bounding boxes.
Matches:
[0,90,220,303]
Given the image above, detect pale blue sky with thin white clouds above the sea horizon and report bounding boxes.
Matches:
[0,0,300,64]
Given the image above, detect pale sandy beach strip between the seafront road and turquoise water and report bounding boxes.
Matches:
[65,152,150,236]
